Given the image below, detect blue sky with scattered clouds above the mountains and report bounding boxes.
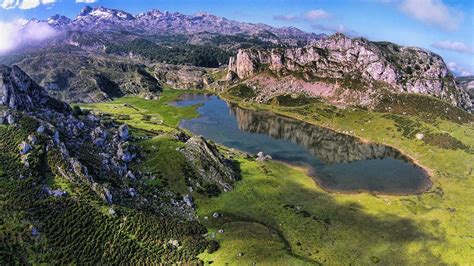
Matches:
[0,0,474,75]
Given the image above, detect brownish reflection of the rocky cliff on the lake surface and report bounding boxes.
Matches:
[228,104,408,164]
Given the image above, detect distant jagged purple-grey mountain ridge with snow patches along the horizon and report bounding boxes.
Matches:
[33,6,326,45]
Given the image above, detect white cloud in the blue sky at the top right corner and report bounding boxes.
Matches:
[400,0,464,31]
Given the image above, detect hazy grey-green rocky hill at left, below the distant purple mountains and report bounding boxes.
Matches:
[1,47,163,102]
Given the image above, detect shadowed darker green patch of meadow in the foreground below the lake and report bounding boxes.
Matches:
[203,165,444,265]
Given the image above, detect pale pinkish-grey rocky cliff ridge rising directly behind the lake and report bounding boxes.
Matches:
[228,34,471,109]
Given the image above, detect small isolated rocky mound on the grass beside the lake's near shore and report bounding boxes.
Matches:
[182,136,239,191]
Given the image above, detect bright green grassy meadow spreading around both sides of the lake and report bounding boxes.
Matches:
[82,91,474,265]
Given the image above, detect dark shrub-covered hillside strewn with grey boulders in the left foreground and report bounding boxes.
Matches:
[0,66,238,264]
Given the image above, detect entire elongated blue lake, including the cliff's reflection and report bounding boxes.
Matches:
[172,94,431,194]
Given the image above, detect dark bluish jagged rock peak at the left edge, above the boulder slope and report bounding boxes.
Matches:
[0,65,71,112]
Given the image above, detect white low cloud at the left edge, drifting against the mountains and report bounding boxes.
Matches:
[0,19,59,54]
